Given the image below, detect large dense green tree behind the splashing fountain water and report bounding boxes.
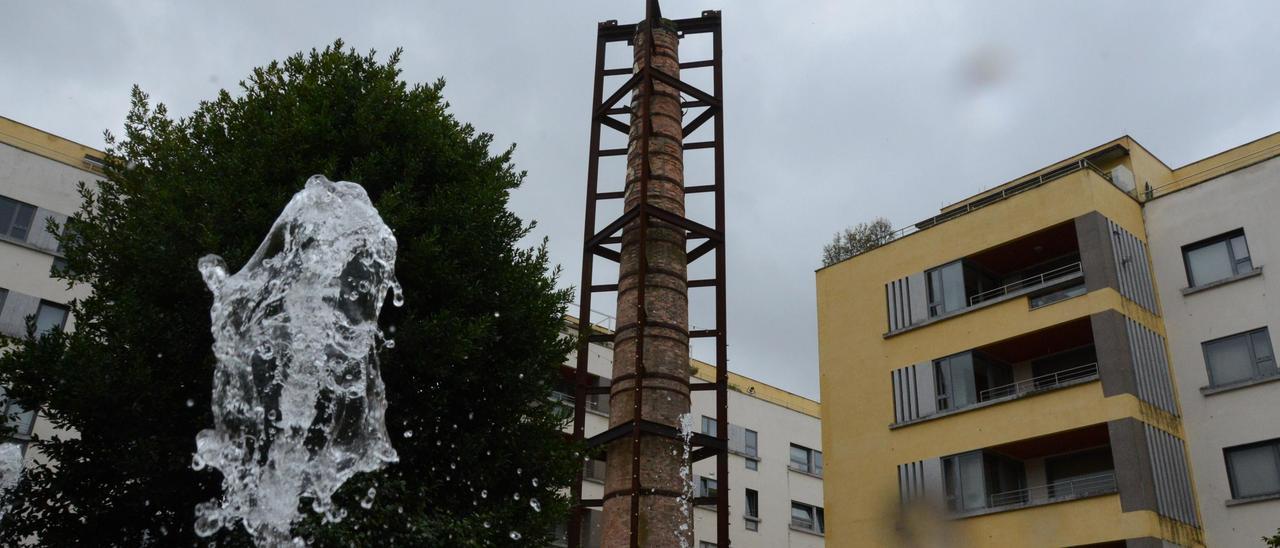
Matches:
[0,41,579,547]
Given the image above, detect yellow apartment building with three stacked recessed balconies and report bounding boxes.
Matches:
[817,136,1280,548]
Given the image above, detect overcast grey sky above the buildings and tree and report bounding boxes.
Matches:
[0,0,1280,398]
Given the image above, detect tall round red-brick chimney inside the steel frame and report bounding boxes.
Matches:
[603,23,692,547]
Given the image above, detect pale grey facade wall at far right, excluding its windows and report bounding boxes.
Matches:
[1144,151,1280,547]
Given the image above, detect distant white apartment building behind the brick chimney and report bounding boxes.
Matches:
[557,312,826,548]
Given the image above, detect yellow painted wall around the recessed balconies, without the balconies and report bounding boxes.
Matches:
[817,166,1176,547]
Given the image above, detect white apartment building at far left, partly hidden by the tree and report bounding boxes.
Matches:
[0,117,104,473]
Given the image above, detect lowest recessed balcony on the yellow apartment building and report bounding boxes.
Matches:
[942,424,1119,519]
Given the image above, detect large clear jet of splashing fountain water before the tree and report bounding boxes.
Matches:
[192,175,403,545]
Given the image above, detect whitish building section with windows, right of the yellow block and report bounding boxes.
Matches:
[1144,140,1280,547]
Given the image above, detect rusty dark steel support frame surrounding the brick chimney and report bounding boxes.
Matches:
[567,5,730,548]
